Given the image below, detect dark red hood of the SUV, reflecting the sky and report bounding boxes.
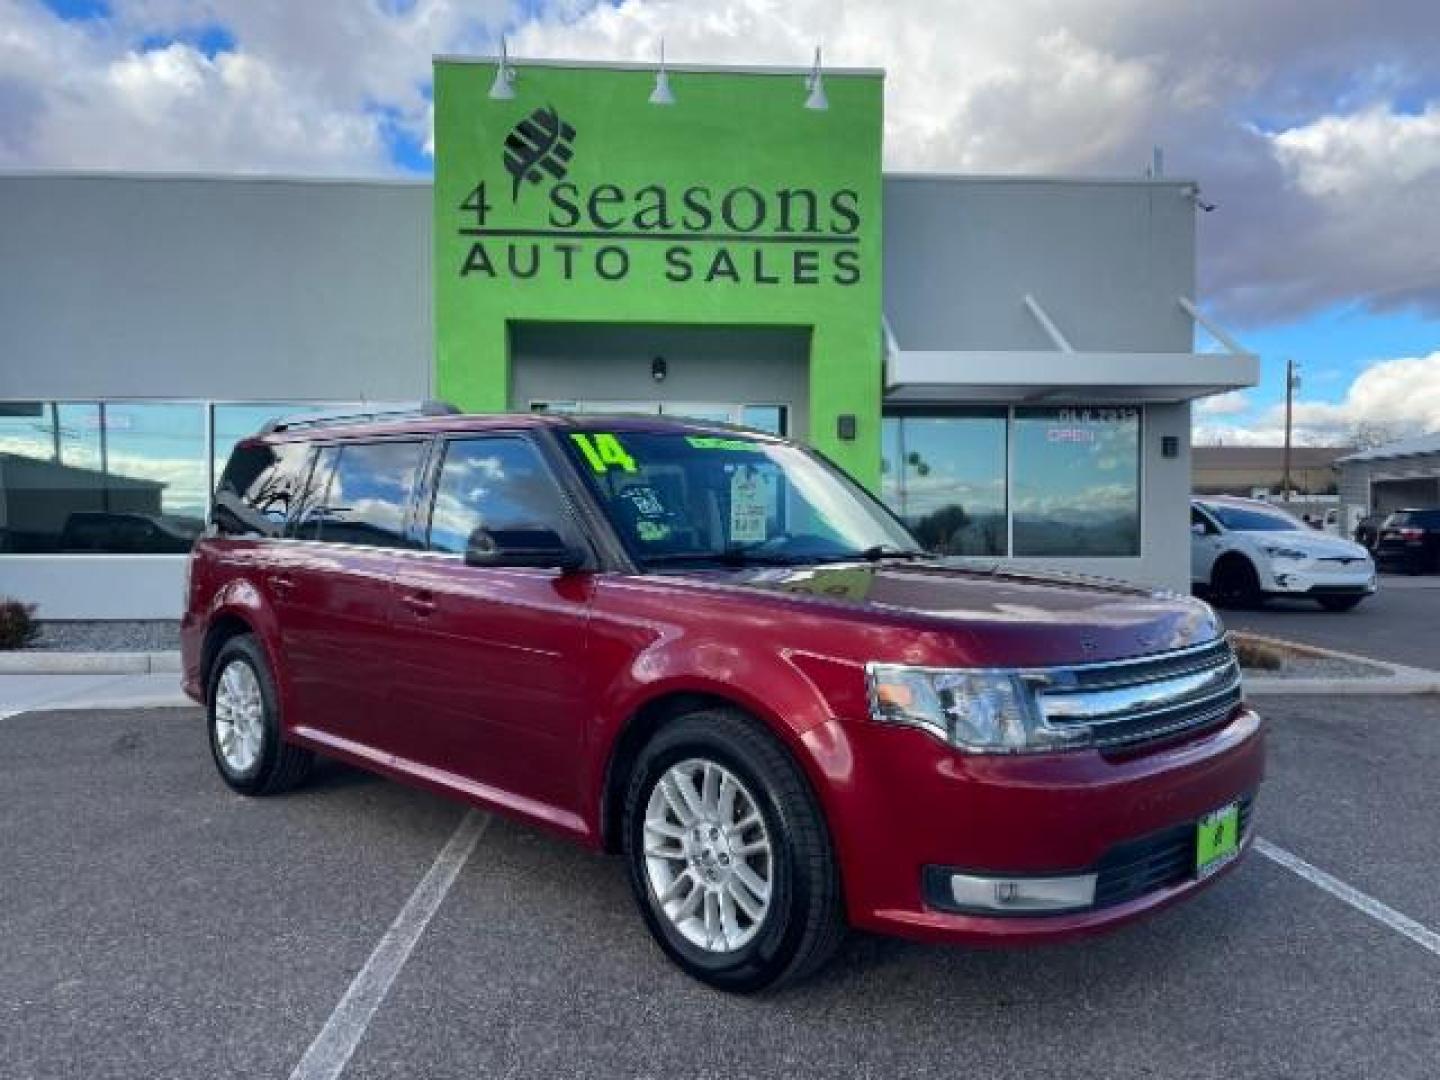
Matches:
[679,562,1224,667]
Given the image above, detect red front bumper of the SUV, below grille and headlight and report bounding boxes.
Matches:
[806,706,1264,946]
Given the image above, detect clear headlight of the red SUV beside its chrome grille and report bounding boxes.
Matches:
[865,664,1089,753]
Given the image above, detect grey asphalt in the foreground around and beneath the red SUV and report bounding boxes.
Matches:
[0,698,1440,1079]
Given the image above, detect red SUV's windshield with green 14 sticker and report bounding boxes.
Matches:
[563,431,917,567]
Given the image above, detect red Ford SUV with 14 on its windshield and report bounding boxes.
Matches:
[183,415,1263,991]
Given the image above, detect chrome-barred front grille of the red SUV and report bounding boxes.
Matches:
[1037,638,1241,747]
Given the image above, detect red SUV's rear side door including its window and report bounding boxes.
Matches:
[271,438,428,759]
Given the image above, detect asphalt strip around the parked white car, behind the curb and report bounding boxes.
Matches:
[1221,573,1440,668]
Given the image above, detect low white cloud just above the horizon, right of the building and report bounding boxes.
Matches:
[1195,350,1440,446]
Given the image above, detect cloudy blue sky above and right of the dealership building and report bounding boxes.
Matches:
[14,0,1440,442]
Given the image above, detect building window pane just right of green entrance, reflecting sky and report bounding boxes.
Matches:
[881,410,1007,556]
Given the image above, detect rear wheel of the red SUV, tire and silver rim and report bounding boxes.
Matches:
[206,634,314,795]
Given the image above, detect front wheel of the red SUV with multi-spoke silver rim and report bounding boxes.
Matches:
[622,708,845,994]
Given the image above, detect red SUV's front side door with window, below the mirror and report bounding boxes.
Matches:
[392,433,593,825]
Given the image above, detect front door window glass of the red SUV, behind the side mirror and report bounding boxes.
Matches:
[431,438,566,553]
